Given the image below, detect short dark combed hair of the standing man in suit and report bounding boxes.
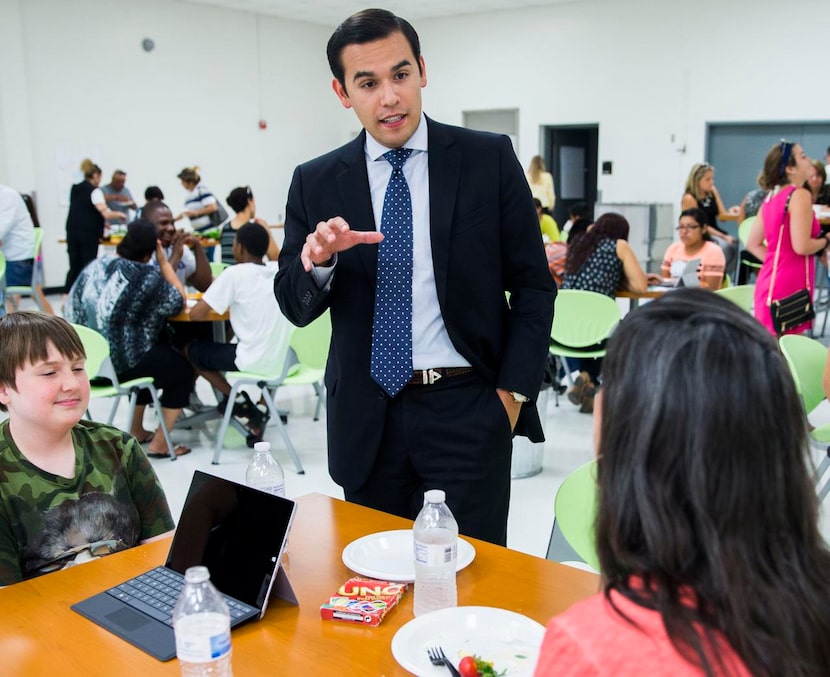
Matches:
[326,9,421,90]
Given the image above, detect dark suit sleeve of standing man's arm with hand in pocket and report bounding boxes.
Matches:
[497,137,556,404]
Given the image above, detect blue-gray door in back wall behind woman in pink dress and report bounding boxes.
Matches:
[706,122,830,219]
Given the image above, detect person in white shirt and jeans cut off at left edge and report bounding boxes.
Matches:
[0,185,35,315]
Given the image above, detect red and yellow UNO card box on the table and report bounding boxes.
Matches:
[320,578,406,627]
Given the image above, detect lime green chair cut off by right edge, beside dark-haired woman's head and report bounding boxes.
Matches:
[779,334,830,502]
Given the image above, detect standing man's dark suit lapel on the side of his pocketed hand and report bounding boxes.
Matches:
[427,118,461,307]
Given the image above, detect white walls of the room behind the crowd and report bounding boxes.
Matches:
[0,0,830,285]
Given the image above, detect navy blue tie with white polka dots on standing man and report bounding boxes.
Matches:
[370,148,412,397]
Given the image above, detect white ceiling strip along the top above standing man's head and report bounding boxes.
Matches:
[173,0,577,27]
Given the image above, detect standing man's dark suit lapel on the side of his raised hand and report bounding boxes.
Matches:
[337,130,378,281]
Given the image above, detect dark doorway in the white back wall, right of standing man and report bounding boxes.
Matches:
[544,125,599,226]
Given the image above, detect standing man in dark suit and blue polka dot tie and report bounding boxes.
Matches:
[274,10,556,544]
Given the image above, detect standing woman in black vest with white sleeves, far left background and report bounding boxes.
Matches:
[65,158,125,292]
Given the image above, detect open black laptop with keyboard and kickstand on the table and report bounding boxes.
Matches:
[71,470,297,661]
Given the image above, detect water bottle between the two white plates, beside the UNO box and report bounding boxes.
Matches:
[413,489,458,616]
